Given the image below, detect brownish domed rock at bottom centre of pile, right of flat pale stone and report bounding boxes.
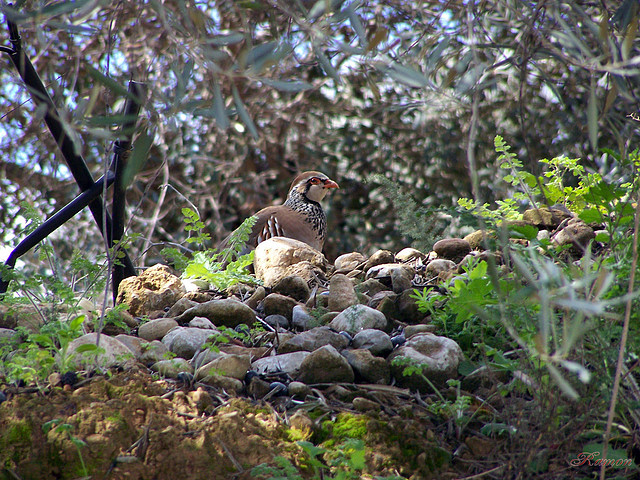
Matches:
[296,345,355,384]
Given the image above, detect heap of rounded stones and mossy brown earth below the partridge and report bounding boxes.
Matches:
[0,211,624,479]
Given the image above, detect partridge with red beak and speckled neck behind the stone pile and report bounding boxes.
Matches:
[247,171,340,251]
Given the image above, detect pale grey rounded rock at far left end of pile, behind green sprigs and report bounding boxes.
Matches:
[66,333,135,369]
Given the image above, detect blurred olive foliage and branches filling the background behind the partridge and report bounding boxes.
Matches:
[0,0,640,269]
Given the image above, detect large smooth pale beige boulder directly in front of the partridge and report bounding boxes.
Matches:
[253,237,327,287]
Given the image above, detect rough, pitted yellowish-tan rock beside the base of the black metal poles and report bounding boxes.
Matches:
[116,265,186,317]
